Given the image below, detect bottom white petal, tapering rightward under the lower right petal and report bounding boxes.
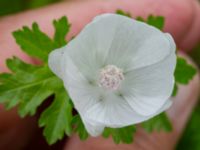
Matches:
[83,95,172,128]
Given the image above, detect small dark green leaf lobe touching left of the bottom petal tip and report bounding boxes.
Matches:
[72,115,89,140]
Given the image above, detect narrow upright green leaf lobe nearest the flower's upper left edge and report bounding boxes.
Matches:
[53,17,71,47]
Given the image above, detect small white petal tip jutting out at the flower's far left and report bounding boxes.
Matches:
[48,47,65,78]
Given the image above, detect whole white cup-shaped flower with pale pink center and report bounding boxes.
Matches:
[49,14,176,136]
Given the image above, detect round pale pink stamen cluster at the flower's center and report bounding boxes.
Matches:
[99,65,124,91]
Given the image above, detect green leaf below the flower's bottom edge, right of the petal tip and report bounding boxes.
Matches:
[102,125,136,144]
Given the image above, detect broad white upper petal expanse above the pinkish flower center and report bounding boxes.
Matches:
[58,14,175,80]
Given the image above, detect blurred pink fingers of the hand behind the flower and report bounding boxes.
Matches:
[0,0,200,150]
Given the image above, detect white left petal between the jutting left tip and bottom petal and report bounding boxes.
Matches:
[63,55,101,114]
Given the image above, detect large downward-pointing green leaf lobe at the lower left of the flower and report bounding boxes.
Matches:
[39,89,72,144]
